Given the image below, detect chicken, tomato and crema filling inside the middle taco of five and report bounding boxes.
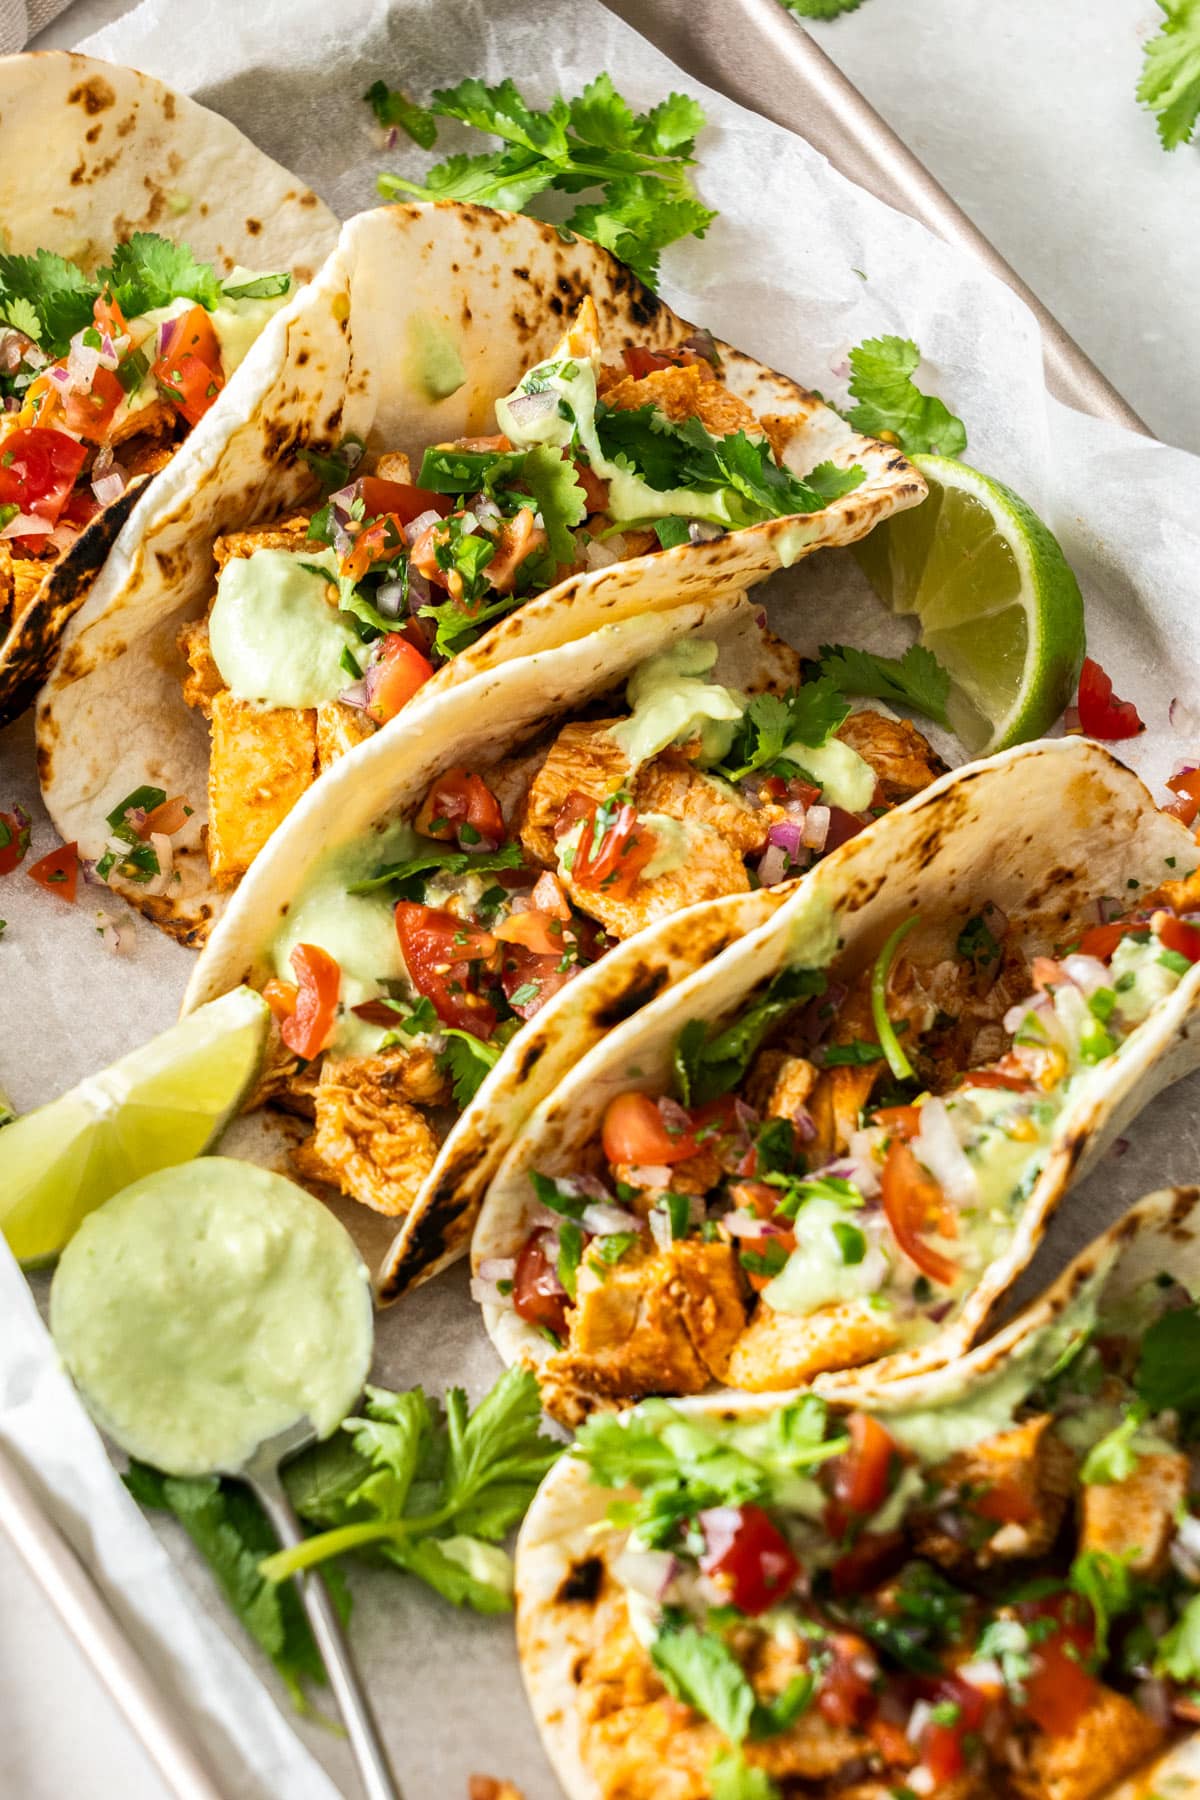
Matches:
[255,619,937,1213]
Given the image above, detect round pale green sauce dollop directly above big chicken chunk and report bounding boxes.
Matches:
[209,549,363,706]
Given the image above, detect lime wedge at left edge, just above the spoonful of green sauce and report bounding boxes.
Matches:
[0,988,270,1265]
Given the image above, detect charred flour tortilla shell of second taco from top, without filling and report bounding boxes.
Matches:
[38,203,925,943]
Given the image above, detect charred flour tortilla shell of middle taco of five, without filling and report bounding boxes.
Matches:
[184,594,793,1300]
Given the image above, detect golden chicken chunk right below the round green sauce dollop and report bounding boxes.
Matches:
[207,688,317,886]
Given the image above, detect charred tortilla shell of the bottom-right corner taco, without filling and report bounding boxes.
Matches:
[516,1188,1200,1800]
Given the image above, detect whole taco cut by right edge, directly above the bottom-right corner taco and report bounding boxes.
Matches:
[471,738,1200,1422]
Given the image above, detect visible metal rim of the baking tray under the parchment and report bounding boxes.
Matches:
[0,0,1150,1800]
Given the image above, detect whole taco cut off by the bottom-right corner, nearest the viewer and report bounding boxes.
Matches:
[516,1188,1200,1800]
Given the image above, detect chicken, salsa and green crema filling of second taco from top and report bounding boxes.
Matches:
[170,301,869,884]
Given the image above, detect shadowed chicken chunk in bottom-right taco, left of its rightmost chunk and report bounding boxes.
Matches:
[914,1413,1076,1570]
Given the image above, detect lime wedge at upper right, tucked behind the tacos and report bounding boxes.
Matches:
[855,455,1085,756]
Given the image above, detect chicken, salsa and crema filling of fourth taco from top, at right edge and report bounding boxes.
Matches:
[503,875,1200,1418]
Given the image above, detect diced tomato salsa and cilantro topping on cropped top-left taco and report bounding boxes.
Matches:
[0,232,291,568]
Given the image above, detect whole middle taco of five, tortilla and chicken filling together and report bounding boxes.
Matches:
[185,594,939,1291]
